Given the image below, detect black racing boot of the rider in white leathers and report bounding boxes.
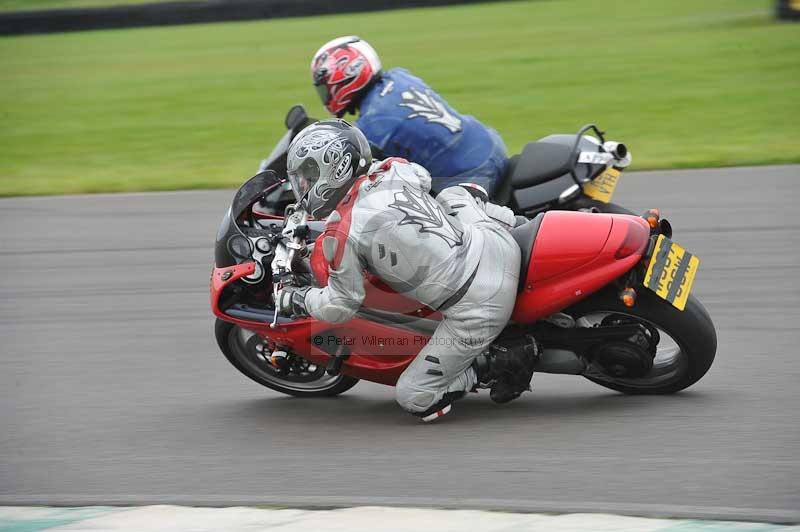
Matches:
[473,335,539,403]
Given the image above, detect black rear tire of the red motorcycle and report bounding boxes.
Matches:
[567,288,717,394]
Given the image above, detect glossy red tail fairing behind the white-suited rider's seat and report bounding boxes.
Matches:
[511,211,650,323]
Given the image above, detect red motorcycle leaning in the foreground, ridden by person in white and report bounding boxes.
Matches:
[211,171,717,402]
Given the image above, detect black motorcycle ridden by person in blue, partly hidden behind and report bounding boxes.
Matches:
[259,105,633,217]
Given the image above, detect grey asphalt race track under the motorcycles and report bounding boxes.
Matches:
[0,166,800,522]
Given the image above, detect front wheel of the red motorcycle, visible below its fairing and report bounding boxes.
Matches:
[214,319,358,397]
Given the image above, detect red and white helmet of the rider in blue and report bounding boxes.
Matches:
[311,35,381,117]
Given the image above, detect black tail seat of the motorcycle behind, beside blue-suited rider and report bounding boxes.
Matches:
[511,140,578,189]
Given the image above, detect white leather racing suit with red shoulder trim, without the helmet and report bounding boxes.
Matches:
[303,158,520,414]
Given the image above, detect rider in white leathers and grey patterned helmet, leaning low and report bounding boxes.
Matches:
[277,120,534,420]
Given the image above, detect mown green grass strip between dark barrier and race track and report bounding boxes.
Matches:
[0,0,800,195]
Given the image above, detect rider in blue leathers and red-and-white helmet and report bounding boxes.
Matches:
[311,37,508,196]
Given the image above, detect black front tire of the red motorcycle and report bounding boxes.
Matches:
[214,319,358,397]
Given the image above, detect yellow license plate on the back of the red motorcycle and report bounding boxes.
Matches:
[644,235,700,310]
